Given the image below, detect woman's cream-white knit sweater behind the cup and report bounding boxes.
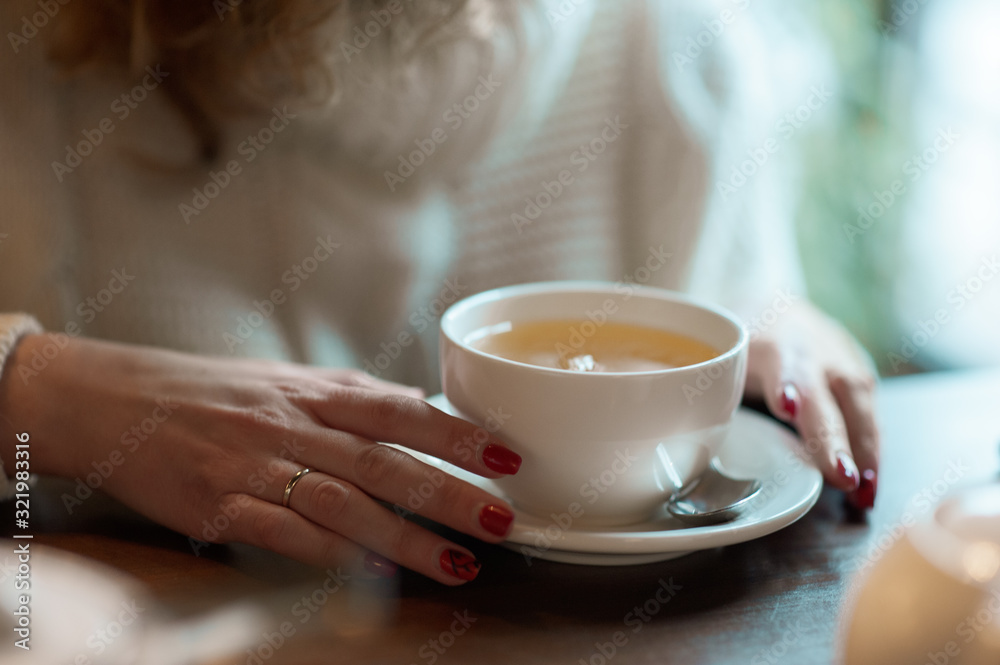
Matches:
[0,0,828,390]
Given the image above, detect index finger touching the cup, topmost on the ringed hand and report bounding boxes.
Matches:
[309,388,521,478]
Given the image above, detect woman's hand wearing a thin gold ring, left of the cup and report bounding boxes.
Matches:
[0,335,521,584]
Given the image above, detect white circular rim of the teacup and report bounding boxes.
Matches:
[440,280,750,381]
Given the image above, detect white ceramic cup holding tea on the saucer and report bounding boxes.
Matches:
[441,282,749,526]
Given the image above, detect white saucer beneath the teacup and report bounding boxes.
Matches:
[407,395,823,566]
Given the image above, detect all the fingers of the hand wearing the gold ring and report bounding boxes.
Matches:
[207,383,520,584]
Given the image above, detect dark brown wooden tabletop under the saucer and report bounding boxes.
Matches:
[7,371,1000,665]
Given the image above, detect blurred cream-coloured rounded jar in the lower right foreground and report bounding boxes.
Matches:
[843,484,1000,665]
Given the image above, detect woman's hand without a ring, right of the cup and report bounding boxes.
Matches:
[747,303,879,508]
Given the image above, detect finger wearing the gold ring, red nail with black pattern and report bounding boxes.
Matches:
[280,472,494,585]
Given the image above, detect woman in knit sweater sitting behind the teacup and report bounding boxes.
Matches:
[0,0,878,584]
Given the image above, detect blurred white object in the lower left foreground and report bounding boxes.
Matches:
[0,538,268,665]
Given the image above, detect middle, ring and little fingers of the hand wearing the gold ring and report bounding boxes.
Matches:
[231,433,514,585]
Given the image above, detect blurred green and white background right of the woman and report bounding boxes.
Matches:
[796,0,1000,375]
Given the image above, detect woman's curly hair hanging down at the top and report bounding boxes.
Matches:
[49,0,476,162]
